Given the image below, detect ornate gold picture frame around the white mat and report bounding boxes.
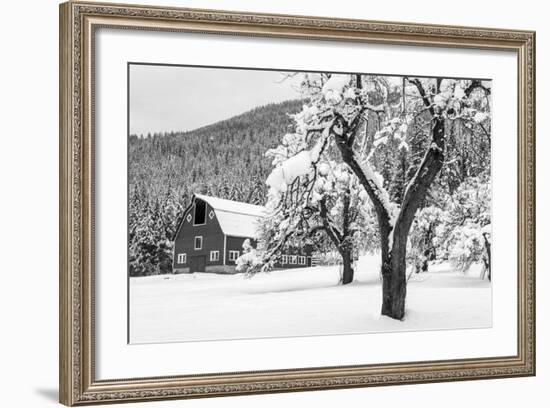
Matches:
[59,2,535,406]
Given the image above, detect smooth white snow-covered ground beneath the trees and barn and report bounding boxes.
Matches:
[129,256,492,344]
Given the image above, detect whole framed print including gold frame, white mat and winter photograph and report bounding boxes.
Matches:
[60,2,535,405]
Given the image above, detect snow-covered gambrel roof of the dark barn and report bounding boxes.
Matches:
[195,194,265,238]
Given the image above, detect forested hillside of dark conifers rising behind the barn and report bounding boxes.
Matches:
[128,100,303,276]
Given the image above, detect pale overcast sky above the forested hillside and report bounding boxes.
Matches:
[130,65,299,135]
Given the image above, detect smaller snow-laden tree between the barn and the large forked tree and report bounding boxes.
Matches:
[239,115,374,284]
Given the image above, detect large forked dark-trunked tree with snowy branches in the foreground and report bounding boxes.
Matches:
[250,74,490,319]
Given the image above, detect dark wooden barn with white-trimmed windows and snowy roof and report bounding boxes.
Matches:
[173,194,311,273]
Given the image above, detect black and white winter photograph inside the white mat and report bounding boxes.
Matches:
[127,62,498,344]
